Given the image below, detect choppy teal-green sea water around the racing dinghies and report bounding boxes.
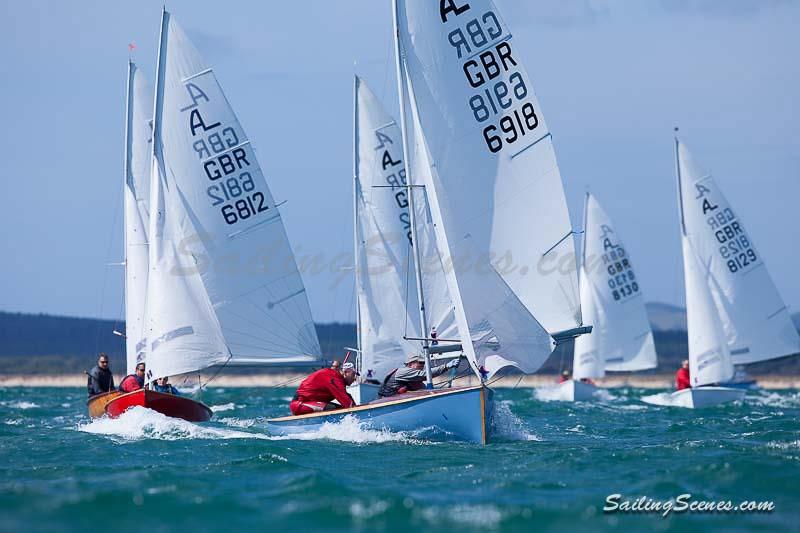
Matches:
[0,388,800,531]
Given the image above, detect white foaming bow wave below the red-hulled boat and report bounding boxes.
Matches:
[77,406,274,441]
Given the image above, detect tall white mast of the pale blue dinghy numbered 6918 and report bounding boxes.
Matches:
[392,0,433,389]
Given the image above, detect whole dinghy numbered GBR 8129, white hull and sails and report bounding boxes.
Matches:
[652,137,800,408]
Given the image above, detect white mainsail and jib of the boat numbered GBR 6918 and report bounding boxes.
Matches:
[395,0,581,373]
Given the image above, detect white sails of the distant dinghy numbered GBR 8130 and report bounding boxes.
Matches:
[573,193,657,379]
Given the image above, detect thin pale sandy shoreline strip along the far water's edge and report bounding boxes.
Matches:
[0,373,800,390]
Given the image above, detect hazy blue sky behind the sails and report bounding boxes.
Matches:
[0,0,800,321]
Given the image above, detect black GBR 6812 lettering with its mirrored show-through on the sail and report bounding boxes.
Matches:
[181,82,269,225]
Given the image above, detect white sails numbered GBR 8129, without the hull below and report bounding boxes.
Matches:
[675,139,800,378]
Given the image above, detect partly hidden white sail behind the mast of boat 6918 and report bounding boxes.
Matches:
[354,77,419,380]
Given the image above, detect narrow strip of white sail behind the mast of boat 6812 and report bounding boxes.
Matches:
[123,61,153,374]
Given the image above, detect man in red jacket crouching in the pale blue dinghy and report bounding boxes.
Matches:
[289,363,358,415]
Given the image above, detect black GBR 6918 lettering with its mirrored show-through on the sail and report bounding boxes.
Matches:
[439,0,539,154]
